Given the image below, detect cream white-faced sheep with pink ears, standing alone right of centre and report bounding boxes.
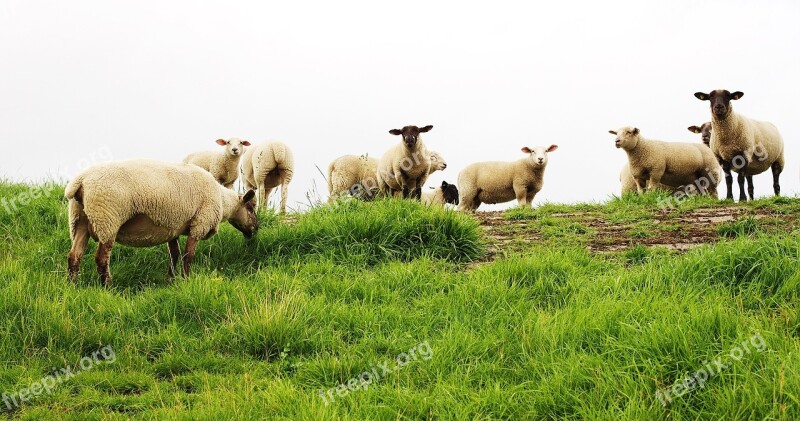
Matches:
[458,145,558,211]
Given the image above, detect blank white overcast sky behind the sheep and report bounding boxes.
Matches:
[0,0,800,209]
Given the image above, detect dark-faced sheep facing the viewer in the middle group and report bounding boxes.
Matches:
[376,126,433,200]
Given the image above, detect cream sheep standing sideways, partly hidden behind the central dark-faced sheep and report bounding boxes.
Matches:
[328,151,447,202]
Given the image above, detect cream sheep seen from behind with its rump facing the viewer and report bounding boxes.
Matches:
[242,142,294,213]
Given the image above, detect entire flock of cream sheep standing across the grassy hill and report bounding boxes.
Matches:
[65,89,785,285]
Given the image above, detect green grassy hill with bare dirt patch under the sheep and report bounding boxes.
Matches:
[0,183,800,420]
